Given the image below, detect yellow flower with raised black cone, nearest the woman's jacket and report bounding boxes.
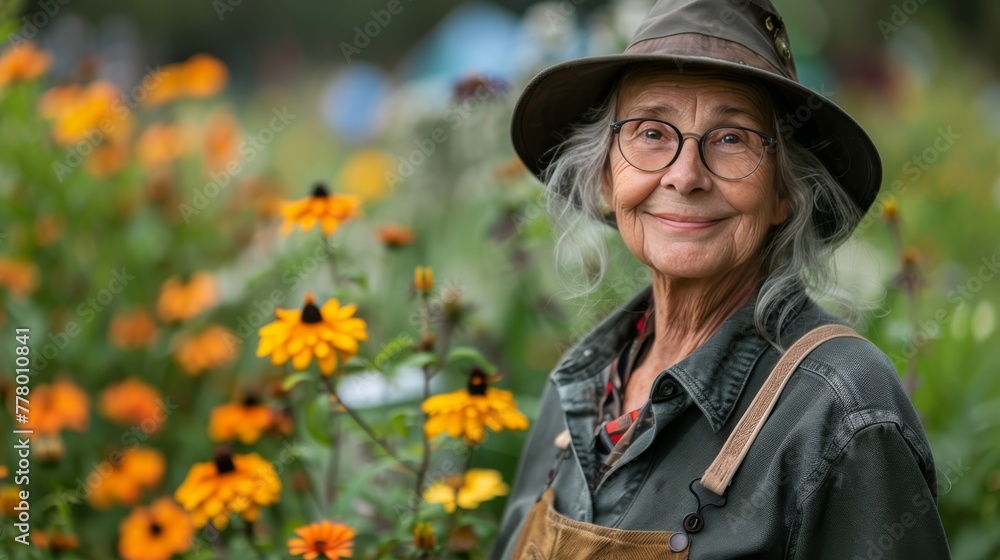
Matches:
[423,368,528,445]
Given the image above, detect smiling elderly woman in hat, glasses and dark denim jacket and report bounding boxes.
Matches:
[494,0,949,560]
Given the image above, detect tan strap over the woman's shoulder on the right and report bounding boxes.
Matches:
[701,325,865,496]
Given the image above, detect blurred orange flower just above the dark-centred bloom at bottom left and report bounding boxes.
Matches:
[87,447,166,509]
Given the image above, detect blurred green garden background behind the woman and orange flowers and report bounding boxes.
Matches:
[0,0,1000,560]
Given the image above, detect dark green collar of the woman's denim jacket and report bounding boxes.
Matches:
[552,284,802,432]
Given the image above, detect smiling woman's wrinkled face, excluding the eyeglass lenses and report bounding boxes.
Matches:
[603,74,789,281]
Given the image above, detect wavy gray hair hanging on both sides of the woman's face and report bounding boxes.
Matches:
[542,70,862,351]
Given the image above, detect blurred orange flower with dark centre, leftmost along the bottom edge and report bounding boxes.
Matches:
[118,498,194,560]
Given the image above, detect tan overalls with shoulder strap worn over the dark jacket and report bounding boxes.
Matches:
[513,325,863,560]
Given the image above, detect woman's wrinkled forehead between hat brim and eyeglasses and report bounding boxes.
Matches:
[615,66,775,128]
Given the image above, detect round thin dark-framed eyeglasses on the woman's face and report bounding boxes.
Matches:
[611,118,775,181]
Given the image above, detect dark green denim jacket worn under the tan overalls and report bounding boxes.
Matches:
[493,286,950,560]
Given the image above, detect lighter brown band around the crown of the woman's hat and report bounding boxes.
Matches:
[625,33,797,81]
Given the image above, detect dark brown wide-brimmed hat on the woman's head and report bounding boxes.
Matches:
[511,0,882,231]
